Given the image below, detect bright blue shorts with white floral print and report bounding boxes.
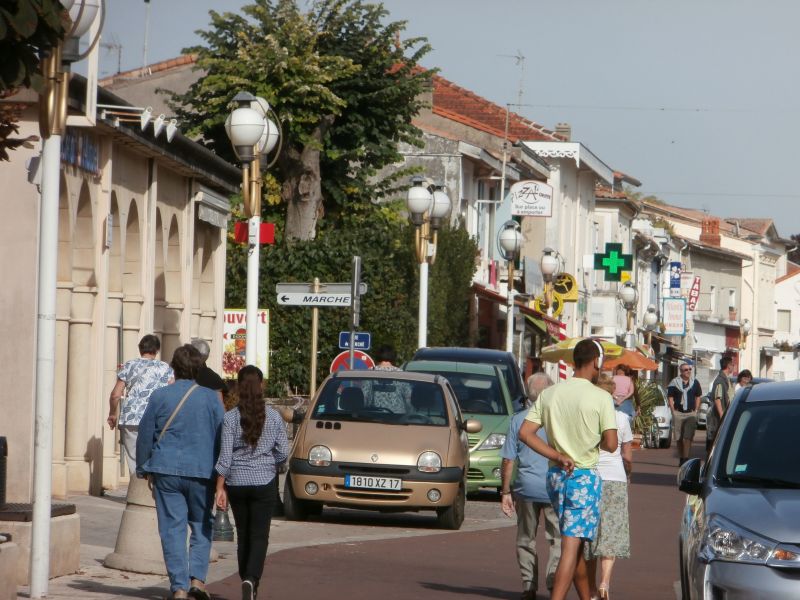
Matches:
[547,467,603,540]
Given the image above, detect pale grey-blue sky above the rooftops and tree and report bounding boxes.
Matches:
[90,0,800,237]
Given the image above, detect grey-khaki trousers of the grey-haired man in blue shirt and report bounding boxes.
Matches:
[514,498,561,592]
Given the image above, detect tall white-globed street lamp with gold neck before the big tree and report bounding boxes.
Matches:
[225,92,281,365]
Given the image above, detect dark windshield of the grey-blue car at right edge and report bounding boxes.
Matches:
[718,400,800,488]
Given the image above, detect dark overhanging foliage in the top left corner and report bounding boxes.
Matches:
[0,0,71,160]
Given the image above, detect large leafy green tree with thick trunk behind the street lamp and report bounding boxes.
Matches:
[172,0,430,242]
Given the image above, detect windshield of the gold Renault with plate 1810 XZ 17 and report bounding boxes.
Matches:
[311,377,448,426]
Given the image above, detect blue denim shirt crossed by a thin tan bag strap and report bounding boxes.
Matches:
[136,379,224,479]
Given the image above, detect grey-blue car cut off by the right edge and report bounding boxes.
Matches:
[678,381,800,600]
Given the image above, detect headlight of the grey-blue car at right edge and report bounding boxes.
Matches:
[700,515,778,565]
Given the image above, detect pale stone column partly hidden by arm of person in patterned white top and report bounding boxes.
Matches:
[101,292,123,489]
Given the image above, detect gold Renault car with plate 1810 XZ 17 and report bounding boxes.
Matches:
[283,370,481,529]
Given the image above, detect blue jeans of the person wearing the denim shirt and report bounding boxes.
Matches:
[153,473,214,593]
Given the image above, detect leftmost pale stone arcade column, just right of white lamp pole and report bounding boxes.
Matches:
[52,281,72,498]
